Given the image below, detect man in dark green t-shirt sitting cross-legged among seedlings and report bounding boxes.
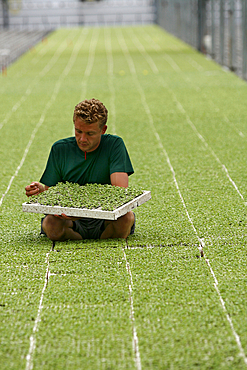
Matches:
[25,99,135,241]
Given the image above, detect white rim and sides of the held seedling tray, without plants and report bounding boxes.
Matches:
[22,191,151,220]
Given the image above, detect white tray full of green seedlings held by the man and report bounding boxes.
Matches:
[22,182,151,219]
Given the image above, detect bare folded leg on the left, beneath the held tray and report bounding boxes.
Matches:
[42,215,82,241]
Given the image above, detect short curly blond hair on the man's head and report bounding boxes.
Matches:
[73,98,108,129]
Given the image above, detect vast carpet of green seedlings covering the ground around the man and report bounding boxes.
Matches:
[0,26,247,370]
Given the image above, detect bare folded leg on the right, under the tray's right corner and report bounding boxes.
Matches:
[100,212,135,239]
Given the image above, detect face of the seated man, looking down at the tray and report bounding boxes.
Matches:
[74,117,107,152]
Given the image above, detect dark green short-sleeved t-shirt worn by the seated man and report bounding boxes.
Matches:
[40,134,134,186]
